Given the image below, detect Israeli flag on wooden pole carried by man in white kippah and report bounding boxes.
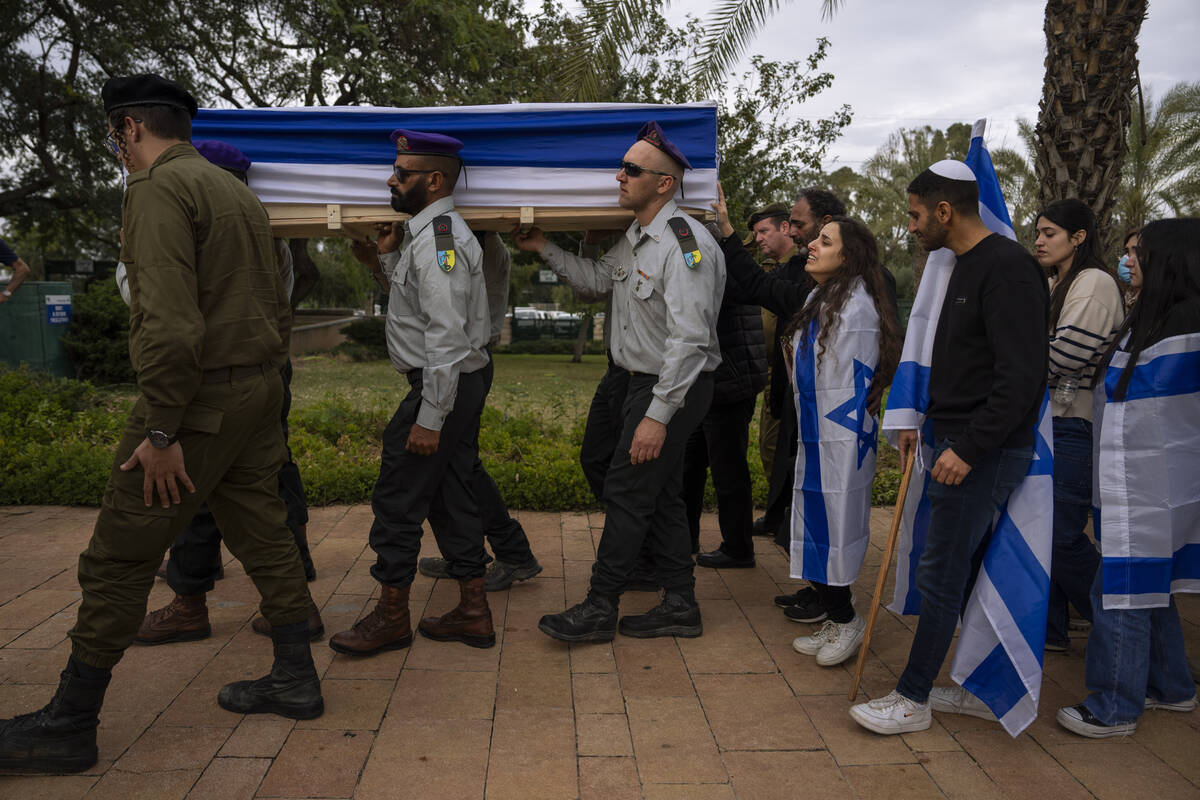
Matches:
[882,120,1054,736]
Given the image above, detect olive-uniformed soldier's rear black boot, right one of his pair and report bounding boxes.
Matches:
[217,620,325,720]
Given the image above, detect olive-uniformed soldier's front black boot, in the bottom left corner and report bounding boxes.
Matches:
[0,656,113,772]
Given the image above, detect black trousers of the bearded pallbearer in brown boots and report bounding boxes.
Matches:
[368,369,487,589]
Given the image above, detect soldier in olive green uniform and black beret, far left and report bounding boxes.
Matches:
[0,76,324,772]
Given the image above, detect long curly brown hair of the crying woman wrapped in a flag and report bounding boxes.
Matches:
[784,216,902,385]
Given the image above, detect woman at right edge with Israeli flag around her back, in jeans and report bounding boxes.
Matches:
[1057,218,1200,739]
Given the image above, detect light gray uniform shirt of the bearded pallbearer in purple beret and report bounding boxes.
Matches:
[379,197,491,431]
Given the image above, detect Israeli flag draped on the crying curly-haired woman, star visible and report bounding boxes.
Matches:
[792,278,880,587]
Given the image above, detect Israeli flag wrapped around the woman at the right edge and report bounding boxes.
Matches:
[1094,333,1200,608]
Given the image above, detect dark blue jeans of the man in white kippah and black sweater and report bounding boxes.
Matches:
[896,439,1033,703]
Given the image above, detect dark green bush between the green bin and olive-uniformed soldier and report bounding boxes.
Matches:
[62,279,137,384]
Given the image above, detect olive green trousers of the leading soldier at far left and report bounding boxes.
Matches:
[70,367,308,668]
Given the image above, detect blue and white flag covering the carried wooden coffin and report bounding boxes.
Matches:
[192,101,716,209]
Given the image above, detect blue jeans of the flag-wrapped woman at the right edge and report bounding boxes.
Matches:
[1084,572,1196,724]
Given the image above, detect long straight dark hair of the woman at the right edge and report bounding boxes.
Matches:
[1103,217,1200,399]
